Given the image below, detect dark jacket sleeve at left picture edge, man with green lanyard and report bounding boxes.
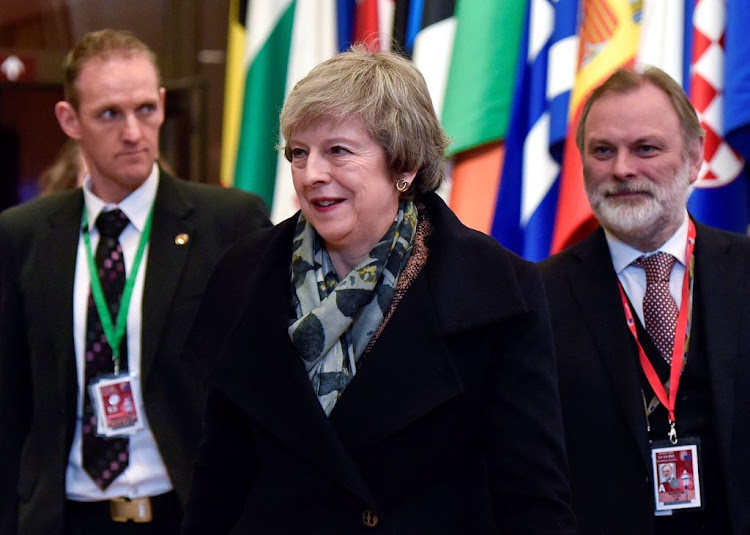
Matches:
[0,218,31,534]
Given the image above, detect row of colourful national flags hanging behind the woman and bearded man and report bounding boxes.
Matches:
[222,0,750,260]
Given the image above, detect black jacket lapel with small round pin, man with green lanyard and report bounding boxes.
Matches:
[141,172,195,384]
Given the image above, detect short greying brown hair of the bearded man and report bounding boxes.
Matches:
[576,67,705,155]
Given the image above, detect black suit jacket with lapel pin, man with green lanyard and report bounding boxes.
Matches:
[0,172,270,534]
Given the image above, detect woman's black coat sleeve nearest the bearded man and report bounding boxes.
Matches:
[484,263,576,534]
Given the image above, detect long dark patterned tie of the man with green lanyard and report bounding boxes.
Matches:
[82,209,129,490]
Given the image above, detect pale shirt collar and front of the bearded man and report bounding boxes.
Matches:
[604,211,688,325]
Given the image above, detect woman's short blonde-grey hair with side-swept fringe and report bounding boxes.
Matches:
[280,45,449,198]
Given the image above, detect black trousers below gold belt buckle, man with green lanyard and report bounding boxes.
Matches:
[63,492,182,535]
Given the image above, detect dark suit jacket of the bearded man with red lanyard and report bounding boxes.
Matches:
[540,223,750,535]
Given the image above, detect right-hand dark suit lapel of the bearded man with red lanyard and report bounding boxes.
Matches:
[688,224,750,481]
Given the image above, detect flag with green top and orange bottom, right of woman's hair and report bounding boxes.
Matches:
[441,0,526,232]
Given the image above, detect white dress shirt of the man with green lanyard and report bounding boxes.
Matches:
[65,164,172,501]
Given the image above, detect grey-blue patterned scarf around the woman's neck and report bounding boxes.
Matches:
[289,201,417,415]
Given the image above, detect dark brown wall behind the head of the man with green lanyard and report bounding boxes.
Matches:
[0,0,229,209]
